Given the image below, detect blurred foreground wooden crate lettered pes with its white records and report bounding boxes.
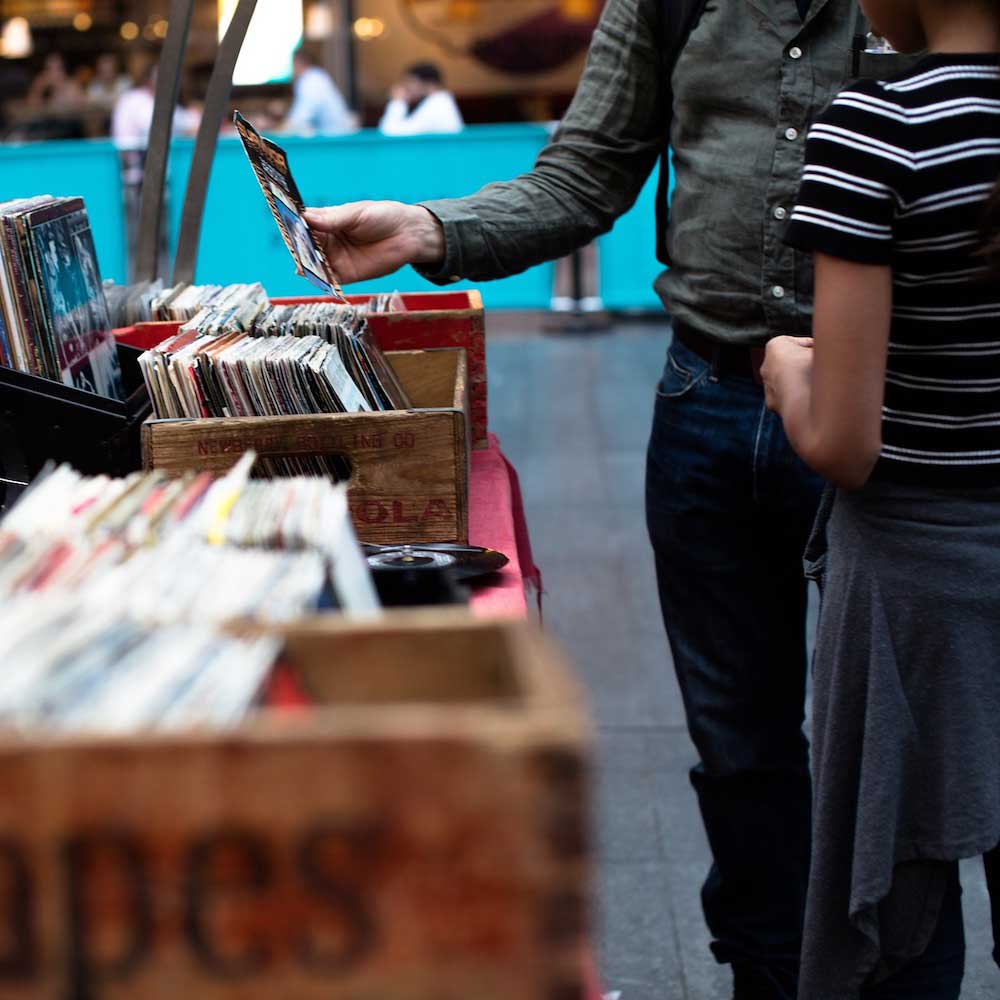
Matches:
[0,458,589,1000]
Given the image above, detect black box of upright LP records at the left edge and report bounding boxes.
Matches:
[0,195,150,509]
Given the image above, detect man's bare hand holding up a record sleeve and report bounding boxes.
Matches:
[305,201,445,285]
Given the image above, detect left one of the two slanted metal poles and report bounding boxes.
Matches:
[134,0,194,281]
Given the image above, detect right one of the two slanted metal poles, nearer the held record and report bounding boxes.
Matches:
[174,0,257,284]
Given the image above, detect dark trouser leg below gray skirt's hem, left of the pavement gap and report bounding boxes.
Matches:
[861,862,964,1000]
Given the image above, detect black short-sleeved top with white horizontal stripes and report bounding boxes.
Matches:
[786,55,1000,486]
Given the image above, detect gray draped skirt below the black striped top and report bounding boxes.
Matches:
[799,484,1000,1000]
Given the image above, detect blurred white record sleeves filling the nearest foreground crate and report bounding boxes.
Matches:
[0,454,378,732]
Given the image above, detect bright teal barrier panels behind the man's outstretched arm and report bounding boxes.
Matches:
[0,125,672,309]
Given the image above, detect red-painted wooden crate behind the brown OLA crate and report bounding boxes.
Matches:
[273,291,489,448]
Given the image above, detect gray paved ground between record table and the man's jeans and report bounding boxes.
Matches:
[488,316,1000,1000]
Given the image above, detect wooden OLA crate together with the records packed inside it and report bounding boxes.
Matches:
[133,285,469,544]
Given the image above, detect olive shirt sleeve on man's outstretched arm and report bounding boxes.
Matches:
[421,0,668,284]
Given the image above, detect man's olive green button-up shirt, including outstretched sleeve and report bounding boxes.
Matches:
[424,0,898,344]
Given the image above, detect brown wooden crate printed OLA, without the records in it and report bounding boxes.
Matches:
[142,349,469,544]
